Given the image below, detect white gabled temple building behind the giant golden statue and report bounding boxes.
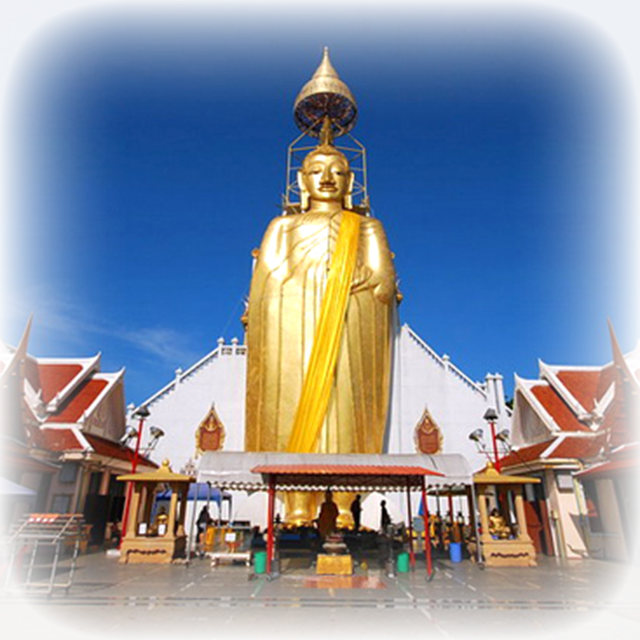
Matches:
[138,324,511,526]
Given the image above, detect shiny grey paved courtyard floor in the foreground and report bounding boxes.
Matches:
[0,552,640,640]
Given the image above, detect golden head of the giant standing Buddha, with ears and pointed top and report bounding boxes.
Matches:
[298,119,354,211]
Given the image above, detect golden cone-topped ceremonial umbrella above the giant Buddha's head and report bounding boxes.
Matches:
[293,47,358,137]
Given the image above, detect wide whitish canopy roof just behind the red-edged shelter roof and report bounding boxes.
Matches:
[197,451,473,491]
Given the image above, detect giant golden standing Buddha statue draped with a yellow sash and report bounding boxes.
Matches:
[245,50,397,521]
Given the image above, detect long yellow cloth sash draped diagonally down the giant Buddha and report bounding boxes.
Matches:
[287,211,361,453]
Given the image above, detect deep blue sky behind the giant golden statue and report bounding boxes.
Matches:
[2,5,640,403]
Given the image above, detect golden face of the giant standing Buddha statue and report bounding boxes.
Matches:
[301,151,351,202]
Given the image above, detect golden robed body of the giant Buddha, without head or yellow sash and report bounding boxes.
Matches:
[245,211,396,453]
